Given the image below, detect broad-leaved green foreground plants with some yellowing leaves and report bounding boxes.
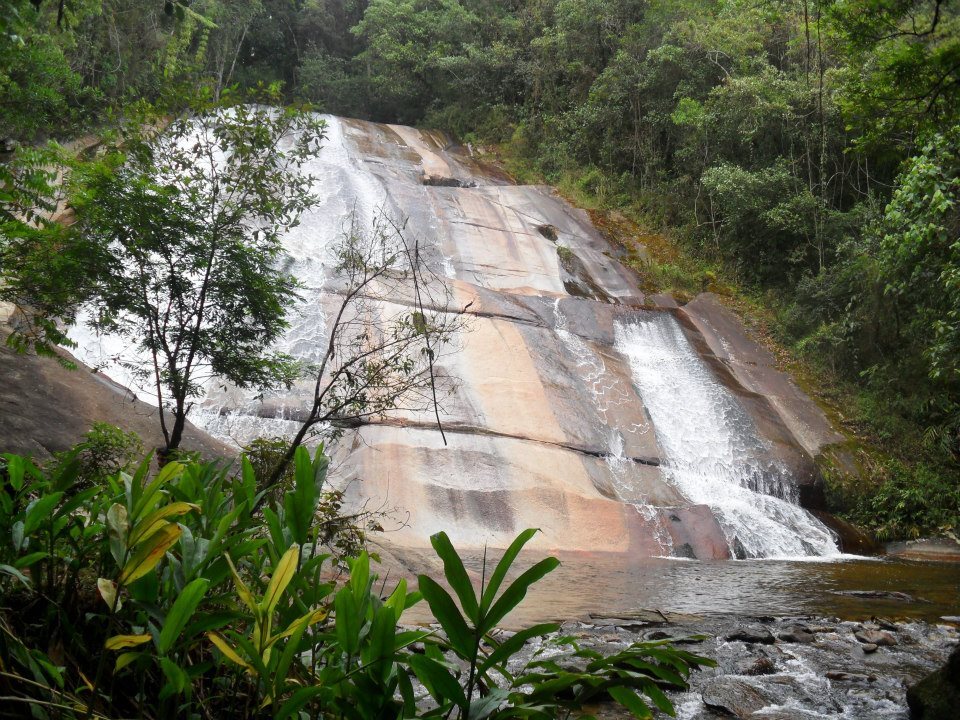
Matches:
[0,426,712,720]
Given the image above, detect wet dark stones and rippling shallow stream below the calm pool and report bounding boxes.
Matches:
[512,612,960,720]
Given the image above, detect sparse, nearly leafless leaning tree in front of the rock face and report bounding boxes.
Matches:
[269,211,469,485]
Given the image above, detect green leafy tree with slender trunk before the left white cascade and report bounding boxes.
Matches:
[6,94,324,453]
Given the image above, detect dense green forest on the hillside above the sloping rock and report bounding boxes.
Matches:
[0,0,960,524]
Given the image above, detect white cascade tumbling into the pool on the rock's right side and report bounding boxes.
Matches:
[616,312,839,558]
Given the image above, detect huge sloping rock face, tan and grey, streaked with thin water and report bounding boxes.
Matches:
[56,118,835,559]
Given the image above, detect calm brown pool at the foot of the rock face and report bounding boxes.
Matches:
[391,551,960,626]
